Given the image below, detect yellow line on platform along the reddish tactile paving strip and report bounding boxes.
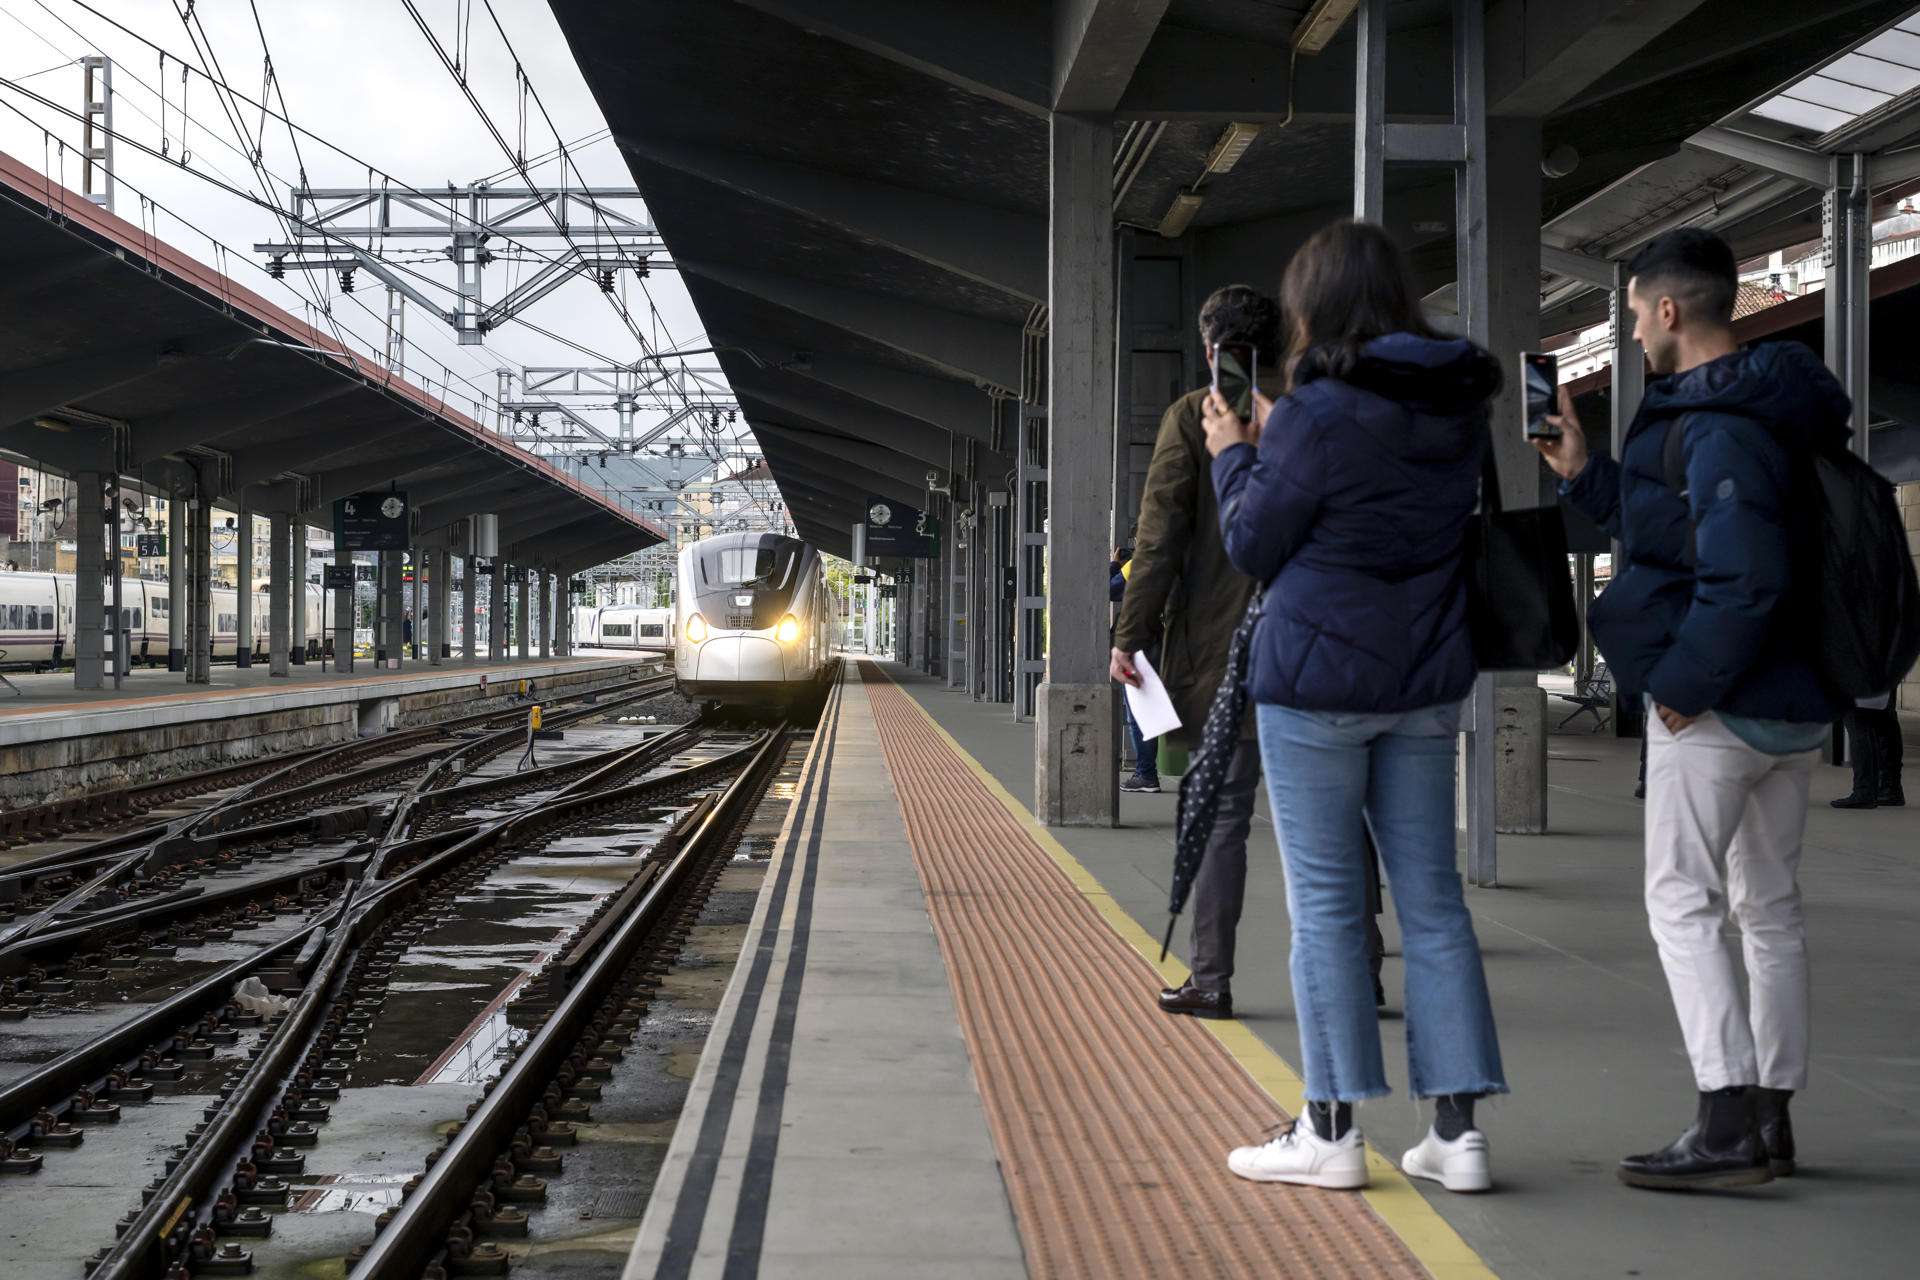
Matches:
[883,685,1494,1280]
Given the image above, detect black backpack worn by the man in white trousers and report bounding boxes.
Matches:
[1661,416,1920,700]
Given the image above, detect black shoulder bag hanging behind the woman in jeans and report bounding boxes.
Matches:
[1463,439,1580,672]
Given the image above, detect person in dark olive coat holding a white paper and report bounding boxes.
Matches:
[1108,284,1281,1017]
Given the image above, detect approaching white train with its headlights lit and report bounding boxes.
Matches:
[674,533,833,706]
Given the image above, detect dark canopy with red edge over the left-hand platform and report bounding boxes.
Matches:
[0,155,664,572]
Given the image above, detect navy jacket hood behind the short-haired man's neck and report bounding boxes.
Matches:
[1644,342,1853,445]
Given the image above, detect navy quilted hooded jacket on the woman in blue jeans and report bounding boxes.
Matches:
[1213,334,1500,712]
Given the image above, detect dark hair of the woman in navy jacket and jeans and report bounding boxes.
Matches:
[1281,219,1440,386]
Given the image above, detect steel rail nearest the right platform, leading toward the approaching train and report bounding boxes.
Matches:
[353,725,787,1280]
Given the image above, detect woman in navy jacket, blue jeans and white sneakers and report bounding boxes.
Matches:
[1206,223,1507,1192]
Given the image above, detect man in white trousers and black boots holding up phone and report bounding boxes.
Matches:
[1534,226,1853,1188]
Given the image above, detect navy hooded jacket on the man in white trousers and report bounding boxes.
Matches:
[1561,342,1853,723]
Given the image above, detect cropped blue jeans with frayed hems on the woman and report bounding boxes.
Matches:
[1260,704,1507,1102]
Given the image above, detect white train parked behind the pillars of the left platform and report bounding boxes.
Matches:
[0,572,324,666]
